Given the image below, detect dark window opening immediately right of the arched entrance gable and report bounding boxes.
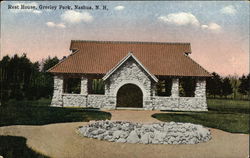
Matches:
[156,78,172,96]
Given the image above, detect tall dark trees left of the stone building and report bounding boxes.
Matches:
[0,54,59,104]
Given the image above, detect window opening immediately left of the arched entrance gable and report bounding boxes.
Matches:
[88,79,104,94]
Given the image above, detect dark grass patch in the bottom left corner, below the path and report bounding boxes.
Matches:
[0,136,48,158]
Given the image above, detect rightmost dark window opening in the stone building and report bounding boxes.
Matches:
[179,77,196,97]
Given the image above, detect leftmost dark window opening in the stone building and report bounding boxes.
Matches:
[63,78,81,94]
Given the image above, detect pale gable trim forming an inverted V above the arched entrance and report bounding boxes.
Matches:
[102,52,158,82]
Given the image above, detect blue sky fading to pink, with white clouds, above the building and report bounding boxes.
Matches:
[1,1,250,76]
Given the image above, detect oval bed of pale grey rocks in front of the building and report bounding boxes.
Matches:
[77,120,212,144]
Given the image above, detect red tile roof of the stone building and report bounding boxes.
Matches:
[49,40,211,77]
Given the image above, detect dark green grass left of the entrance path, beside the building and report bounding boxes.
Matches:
[0,101,111,126]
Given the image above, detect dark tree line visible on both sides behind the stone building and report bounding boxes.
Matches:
[0,54,250,103]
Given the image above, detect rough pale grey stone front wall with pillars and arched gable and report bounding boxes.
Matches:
[51,58,207,111]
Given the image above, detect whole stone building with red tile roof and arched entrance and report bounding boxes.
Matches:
[48,40,211,111]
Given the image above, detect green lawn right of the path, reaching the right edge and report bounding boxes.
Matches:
[152,99,250,133]
